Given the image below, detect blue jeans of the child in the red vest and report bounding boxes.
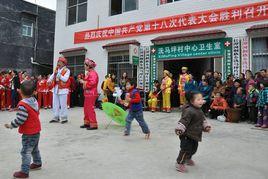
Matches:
[21,133,42,174]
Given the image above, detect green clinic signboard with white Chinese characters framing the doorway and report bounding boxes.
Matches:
[151,38,232,79]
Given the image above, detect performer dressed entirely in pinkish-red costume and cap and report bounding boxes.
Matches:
[79,58,99,130]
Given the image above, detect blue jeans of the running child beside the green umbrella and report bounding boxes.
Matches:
[125,110,150,135]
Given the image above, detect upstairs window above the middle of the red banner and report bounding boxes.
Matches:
[110,0,138,16]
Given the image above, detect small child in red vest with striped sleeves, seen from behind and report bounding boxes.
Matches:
[5,80,42,178]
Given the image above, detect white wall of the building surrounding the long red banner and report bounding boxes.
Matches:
[54,0,267,86]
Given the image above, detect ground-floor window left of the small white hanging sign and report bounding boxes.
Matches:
[108,52,137,84]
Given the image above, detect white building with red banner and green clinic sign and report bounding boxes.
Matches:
[54,0,268,88]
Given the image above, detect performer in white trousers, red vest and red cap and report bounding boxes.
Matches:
[47,57,70,124]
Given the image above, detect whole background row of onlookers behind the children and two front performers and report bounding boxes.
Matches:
[0,67,268,128]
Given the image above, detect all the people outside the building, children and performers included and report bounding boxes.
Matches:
[0,57,268,178]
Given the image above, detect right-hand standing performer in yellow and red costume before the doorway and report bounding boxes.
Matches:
[178,67,190,107]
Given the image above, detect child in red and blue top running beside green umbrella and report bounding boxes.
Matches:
[124,81,150,139]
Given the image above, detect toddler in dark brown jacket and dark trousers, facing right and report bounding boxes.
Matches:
[175,92,211,173]
